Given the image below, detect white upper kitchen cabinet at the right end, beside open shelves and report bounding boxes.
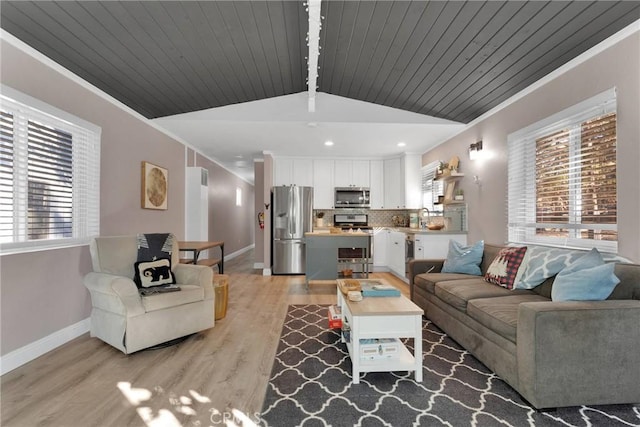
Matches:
[384,154,422,209]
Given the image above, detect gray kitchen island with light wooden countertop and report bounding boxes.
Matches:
[304,232,371,285]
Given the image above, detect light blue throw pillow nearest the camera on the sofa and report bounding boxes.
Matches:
[551,248,620,301]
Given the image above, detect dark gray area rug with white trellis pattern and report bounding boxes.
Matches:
[261,305,640,427]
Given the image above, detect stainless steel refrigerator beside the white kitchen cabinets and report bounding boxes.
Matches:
[271,186,313,274]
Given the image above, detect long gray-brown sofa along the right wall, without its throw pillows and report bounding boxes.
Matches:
[409,244,640,409]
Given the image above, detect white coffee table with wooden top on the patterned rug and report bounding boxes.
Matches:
[336,279,424,384]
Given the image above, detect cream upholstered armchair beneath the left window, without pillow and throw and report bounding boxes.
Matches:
[84,235,215,354]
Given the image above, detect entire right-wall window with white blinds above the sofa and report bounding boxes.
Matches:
[508,90,618,253]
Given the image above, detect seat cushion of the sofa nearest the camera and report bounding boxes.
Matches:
[467,293,549,343]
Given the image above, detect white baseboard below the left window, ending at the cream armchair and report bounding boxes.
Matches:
[0,317,91,375]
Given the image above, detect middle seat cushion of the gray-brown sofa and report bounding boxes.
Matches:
[435,277,532,312]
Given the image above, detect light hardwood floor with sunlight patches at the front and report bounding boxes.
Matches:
[0,251,408,427]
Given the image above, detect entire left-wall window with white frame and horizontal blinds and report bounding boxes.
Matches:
[0,86,100,254]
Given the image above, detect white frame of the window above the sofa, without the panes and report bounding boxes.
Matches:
[507,88,618,253]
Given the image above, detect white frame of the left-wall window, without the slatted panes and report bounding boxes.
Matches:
[0,85,102,255]
